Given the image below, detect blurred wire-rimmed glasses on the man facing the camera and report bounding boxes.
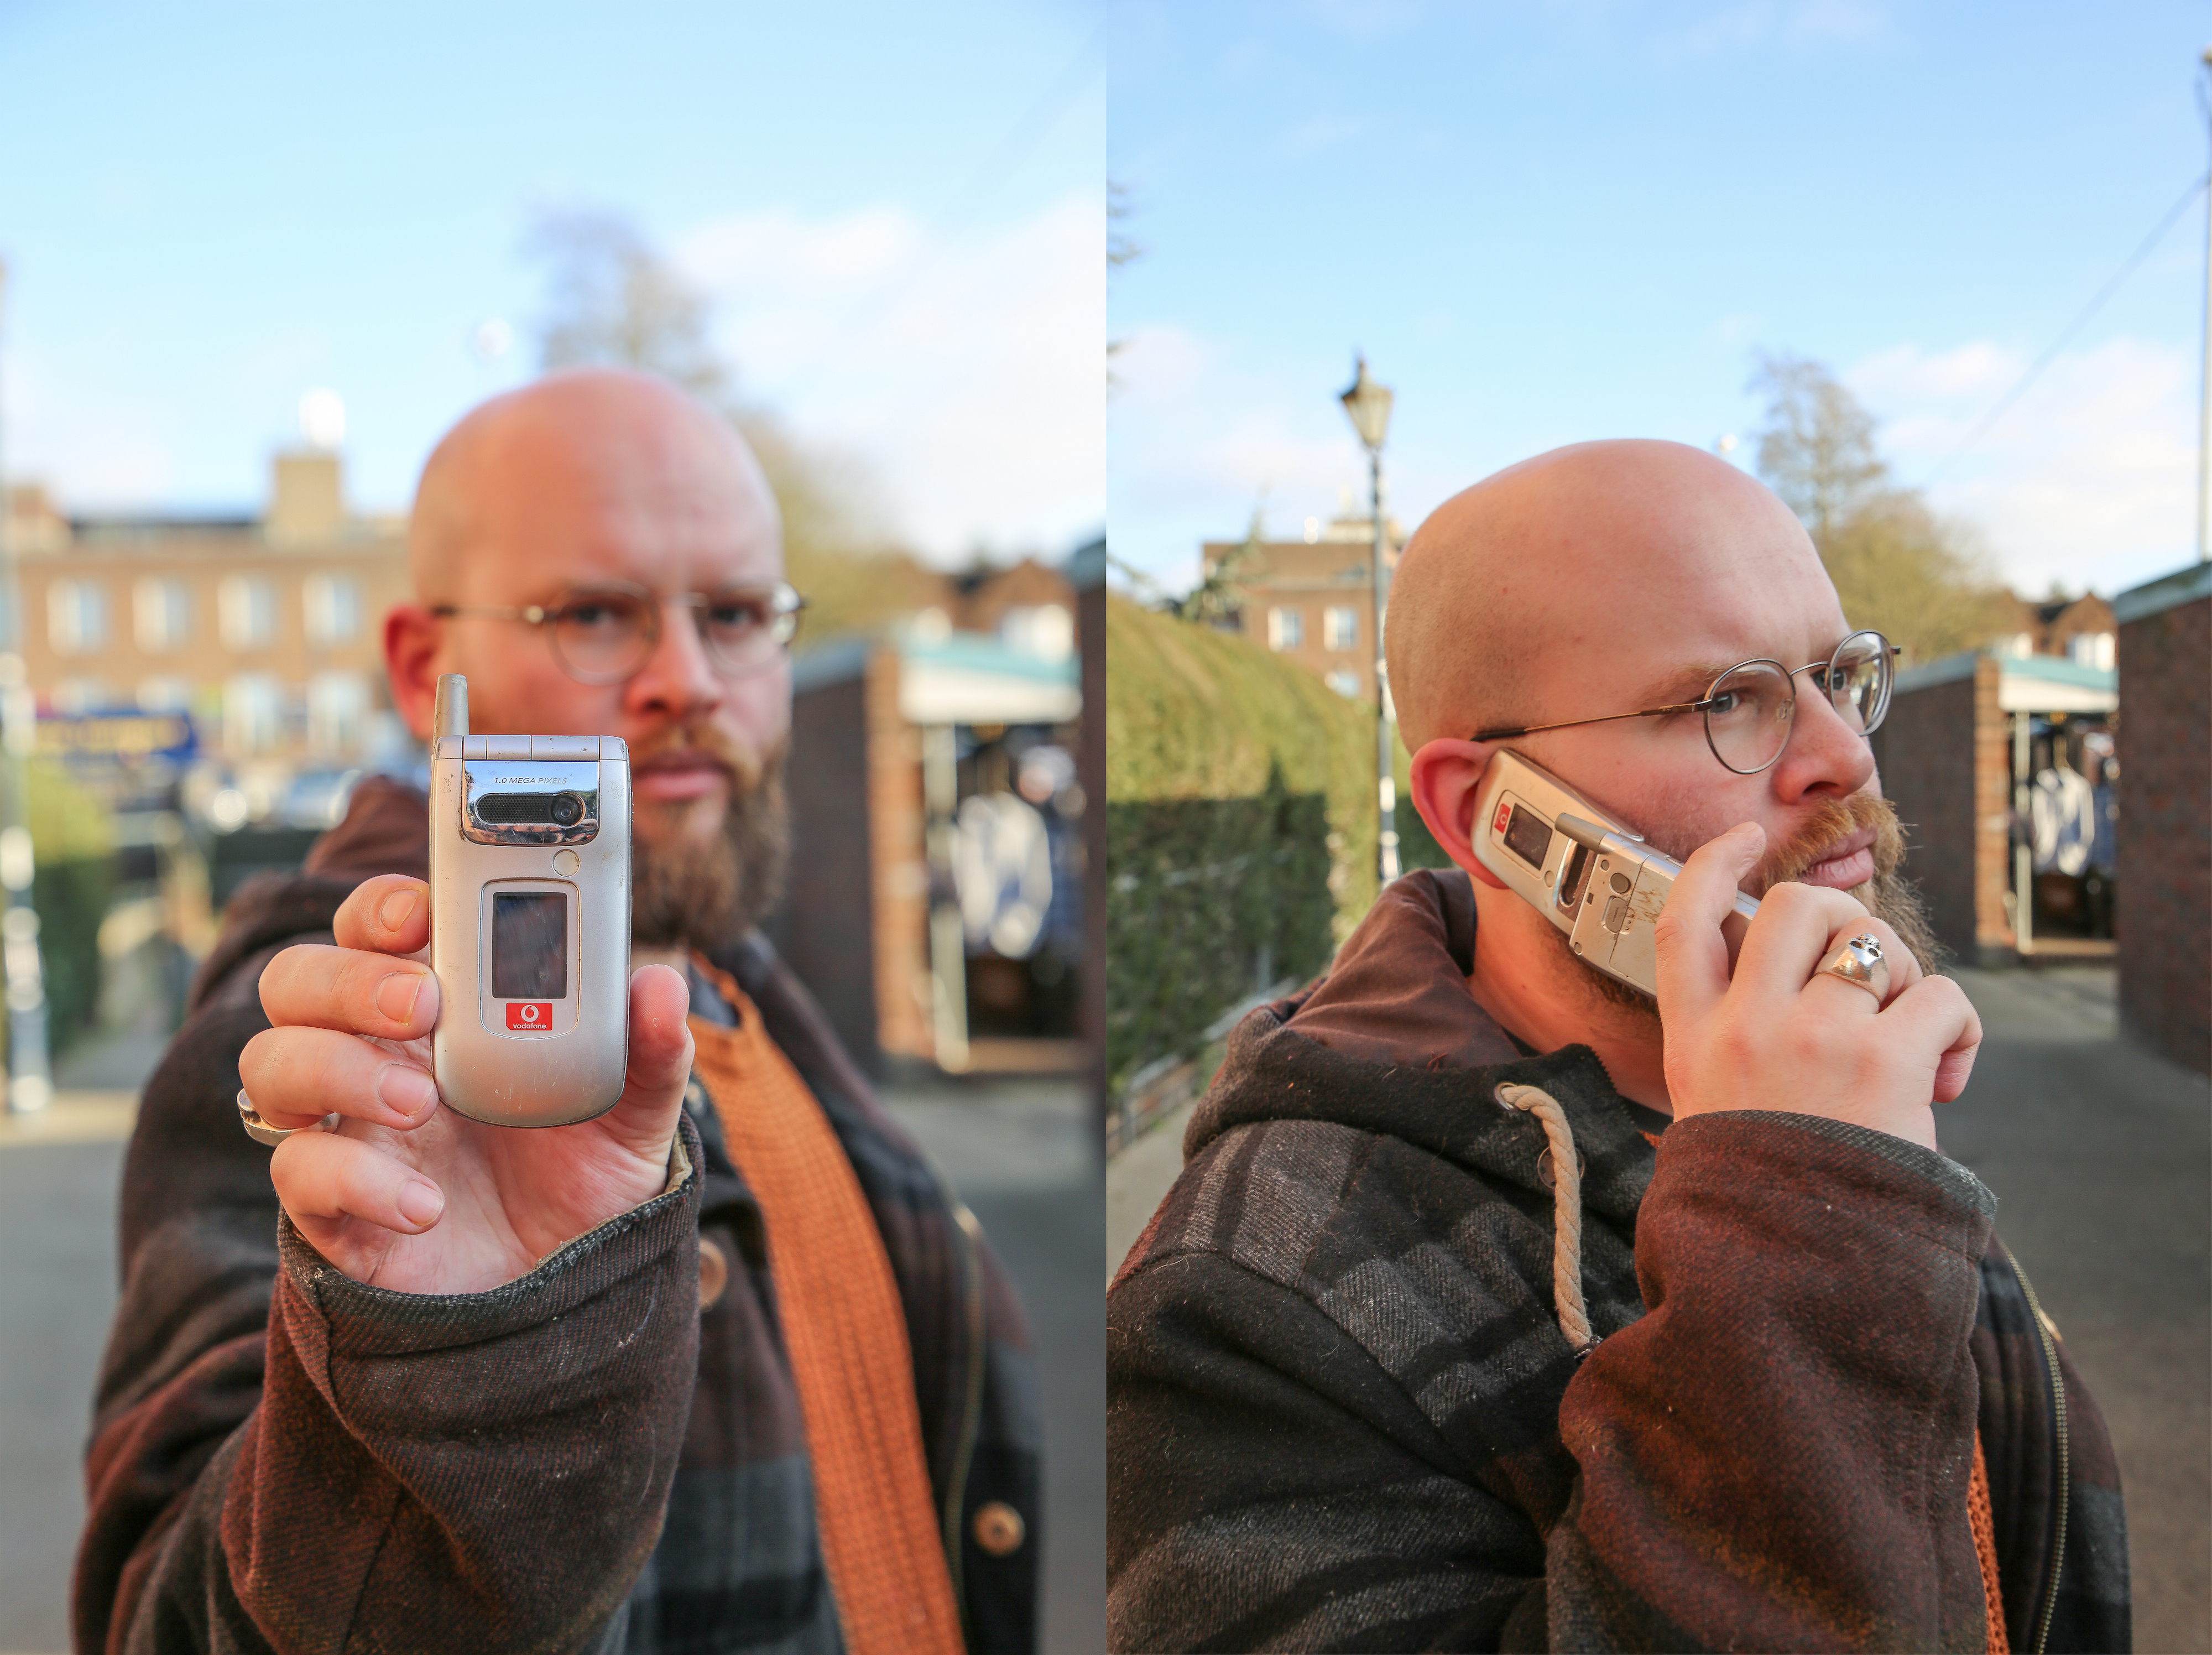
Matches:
[431,580,807,684]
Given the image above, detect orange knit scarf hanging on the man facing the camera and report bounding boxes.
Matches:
[690,960,962,1655]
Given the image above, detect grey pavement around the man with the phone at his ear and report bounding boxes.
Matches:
[1106,967,2212,1651]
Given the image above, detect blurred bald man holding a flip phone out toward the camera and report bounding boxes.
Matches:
[75,372,1037,1651]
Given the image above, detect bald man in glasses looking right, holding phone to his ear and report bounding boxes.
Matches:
[1108,443,2128,1651]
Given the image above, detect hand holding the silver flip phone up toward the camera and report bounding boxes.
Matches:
[239,876,692,1292]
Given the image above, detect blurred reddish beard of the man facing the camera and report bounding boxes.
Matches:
[630,726,790,951]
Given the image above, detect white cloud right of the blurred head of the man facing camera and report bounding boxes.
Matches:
[677,195,1106,562]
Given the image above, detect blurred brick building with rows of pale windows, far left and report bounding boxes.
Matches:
[7,451,407,766]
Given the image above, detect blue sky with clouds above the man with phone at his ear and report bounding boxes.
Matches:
[1108,0,2212,595]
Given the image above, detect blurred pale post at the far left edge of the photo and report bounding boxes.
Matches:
[0,261,53,1115]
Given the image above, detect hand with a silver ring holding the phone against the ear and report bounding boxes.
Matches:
[1652,823,1982,1148]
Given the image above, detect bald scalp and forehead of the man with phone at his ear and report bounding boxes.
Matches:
[1385,440,1840,752]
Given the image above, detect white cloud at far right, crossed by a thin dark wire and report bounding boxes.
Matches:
[1845,339,2197,595]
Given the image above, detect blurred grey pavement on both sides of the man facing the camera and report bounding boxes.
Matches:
[0,1075,1106,1655]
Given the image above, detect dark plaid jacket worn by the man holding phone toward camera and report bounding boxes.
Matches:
[73,783,1040,1655]
